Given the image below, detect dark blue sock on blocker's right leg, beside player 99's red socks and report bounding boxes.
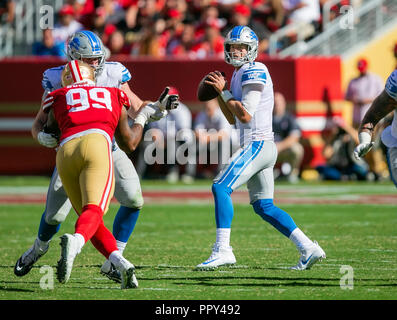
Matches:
[113,206,140,242]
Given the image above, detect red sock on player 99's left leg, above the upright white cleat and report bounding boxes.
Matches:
[75,204,103,242]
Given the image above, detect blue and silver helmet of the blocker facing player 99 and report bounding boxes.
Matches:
[66,31,106,74]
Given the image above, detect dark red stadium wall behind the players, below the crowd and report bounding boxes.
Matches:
[0,57,343,174]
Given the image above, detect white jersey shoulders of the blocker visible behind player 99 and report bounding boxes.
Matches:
[42,62,131,92]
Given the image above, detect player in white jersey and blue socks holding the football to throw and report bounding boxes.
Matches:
[197,26,325,270]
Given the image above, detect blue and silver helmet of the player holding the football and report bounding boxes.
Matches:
[224,26,258,67]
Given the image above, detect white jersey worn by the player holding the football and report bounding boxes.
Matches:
[230,62,274,146]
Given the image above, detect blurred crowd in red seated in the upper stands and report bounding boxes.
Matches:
[20,0,357,59]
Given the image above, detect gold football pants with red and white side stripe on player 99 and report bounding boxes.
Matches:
[56,133,114,215]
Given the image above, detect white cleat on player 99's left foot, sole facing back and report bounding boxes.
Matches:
[57,233,81,283]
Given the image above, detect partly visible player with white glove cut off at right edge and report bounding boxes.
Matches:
[353,70,397,187]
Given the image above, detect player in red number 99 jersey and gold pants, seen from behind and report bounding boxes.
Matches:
[42,60,177,289]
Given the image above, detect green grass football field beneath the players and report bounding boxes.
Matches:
[0,177,397,300]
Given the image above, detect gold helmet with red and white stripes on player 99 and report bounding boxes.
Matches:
[61,60,95,87]
